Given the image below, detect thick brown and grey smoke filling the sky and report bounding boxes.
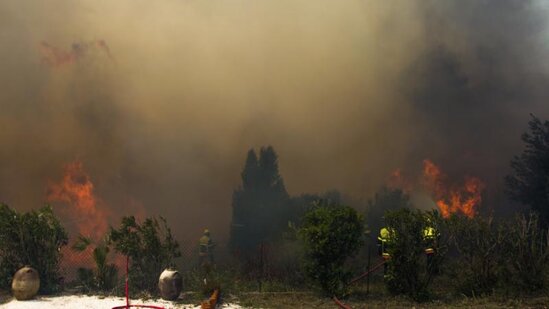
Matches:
[0,0,549,239]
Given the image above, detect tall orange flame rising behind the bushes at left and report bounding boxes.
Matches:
[46,161,108,240]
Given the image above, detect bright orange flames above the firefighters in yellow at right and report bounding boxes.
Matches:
[423,160,484,218]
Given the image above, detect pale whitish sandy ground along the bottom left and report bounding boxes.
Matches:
[0,295,242,309]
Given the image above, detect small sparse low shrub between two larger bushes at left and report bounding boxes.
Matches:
[72,235,118,291]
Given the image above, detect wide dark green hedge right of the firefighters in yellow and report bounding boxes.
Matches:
[449,213,549,296]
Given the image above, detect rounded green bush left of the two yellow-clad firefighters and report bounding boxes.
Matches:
[299,202,364,296]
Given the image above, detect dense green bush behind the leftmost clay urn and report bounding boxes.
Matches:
[0,204,67,294]
